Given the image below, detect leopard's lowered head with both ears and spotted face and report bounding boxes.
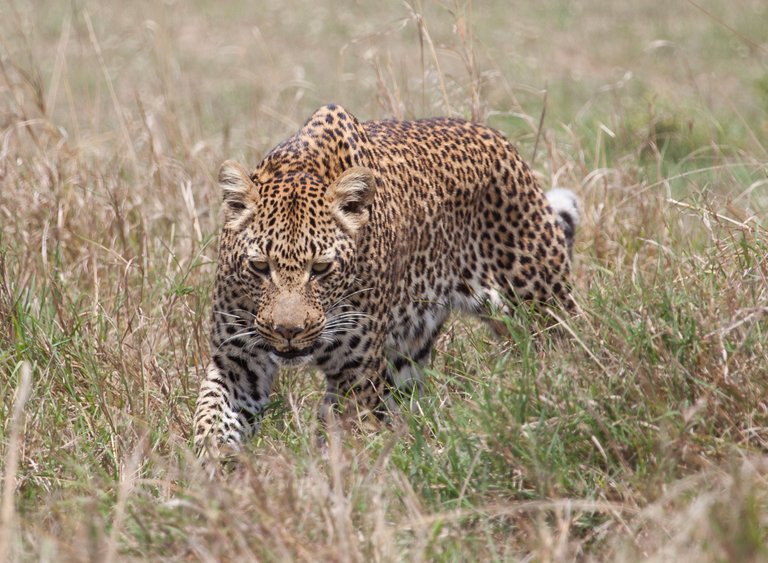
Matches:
[214,161,376,363]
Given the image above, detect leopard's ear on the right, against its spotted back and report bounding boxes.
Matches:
[327,166,376,235]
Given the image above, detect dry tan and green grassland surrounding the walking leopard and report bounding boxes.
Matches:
[0,0,768,561]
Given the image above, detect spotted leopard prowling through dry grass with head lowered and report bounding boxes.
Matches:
[193,104,579,458]
